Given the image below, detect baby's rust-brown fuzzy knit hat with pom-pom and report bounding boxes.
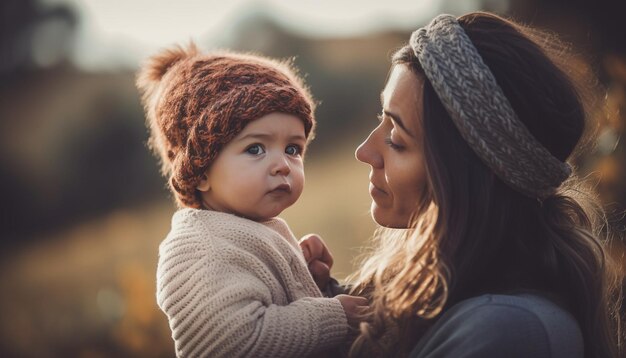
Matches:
[137,43,315,208]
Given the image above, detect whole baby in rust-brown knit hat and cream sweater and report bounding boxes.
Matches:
[137,44,367,357]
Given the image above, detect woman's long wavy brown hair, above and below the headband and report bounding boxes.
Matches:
[349,12,623,357]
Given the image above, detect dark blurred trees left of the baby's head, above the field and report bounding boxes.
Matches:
[0,0,164,245]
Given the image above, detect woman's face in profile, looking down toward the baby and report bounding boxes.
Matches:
[356,65,426,228]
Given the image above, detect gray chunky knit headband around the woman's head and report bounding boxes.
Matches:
[410,15,572,198]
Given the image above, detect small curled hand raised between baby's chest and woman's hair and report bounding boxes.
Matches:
[300,234,333,291]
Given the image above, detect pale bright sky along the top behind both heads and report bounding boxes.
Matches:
[42,0,476,69]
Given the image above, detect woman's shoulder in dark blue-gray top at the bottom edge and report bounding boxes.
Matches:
[410,294,583,357]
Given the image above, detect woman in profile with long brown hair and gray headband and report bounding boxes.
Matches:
[351,13,620,357]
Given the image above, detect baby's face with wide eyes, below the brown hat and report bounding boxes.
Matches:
[198,113,306,221]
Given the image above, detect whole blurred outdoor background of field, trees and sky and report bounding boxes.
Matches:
[0,0,626,357]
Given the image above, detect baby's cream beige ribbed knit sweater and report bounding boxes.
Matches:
[157,209,348,357]
